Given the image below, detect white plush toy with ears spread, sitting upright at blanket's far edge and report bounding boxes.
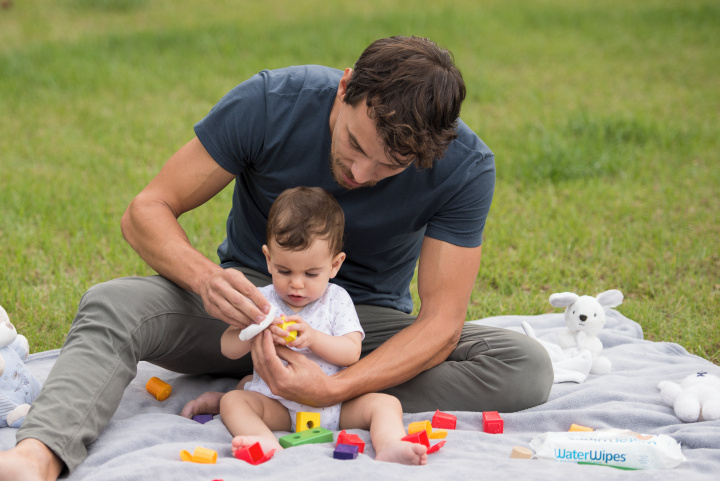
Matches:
[550,289,623,374]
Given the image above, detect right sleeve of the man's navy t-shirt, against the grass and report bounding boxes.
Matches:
[425,153,495,247]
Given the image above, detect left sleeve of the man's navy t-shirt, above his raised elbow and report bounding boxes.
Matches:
[195,72,267,175]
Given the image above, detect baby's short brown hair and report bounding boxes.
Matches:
[266,187,345,256]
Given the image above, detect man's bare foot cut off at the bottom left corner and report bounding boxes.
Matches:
[0,439,64,481]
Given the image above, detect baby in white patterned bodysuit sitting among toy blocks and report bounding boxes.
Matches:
[220,187,427,465]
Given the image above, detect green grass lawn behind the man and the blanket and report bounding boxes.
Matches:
[0,0,720,363]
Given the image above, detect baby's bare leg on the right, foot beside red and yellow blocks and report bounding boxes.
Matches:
[340,393,427,465]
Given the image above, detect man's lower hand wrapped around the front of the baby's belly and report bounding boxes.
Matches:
[251,330,341,407]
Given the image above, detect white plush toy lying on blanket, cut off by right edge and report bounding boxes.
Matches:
[658,371,720,423]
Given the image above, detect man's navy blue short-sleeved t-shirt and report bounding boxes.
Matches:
[195,65,495,313]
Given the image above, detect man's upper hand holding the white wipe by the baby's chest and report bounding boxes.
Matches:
[198,268,270,329]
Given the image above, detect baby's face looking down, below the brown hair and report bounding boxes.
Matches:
[263,239,345,312]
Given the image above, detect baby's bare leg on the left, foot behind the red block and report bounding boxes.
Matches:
[220,391,290,454]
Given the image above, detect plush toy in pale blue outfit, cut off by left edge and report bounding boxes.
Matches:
[0,306,41,428]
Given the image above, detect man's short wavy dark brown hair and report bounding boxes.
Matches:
[344,37,465,168]
